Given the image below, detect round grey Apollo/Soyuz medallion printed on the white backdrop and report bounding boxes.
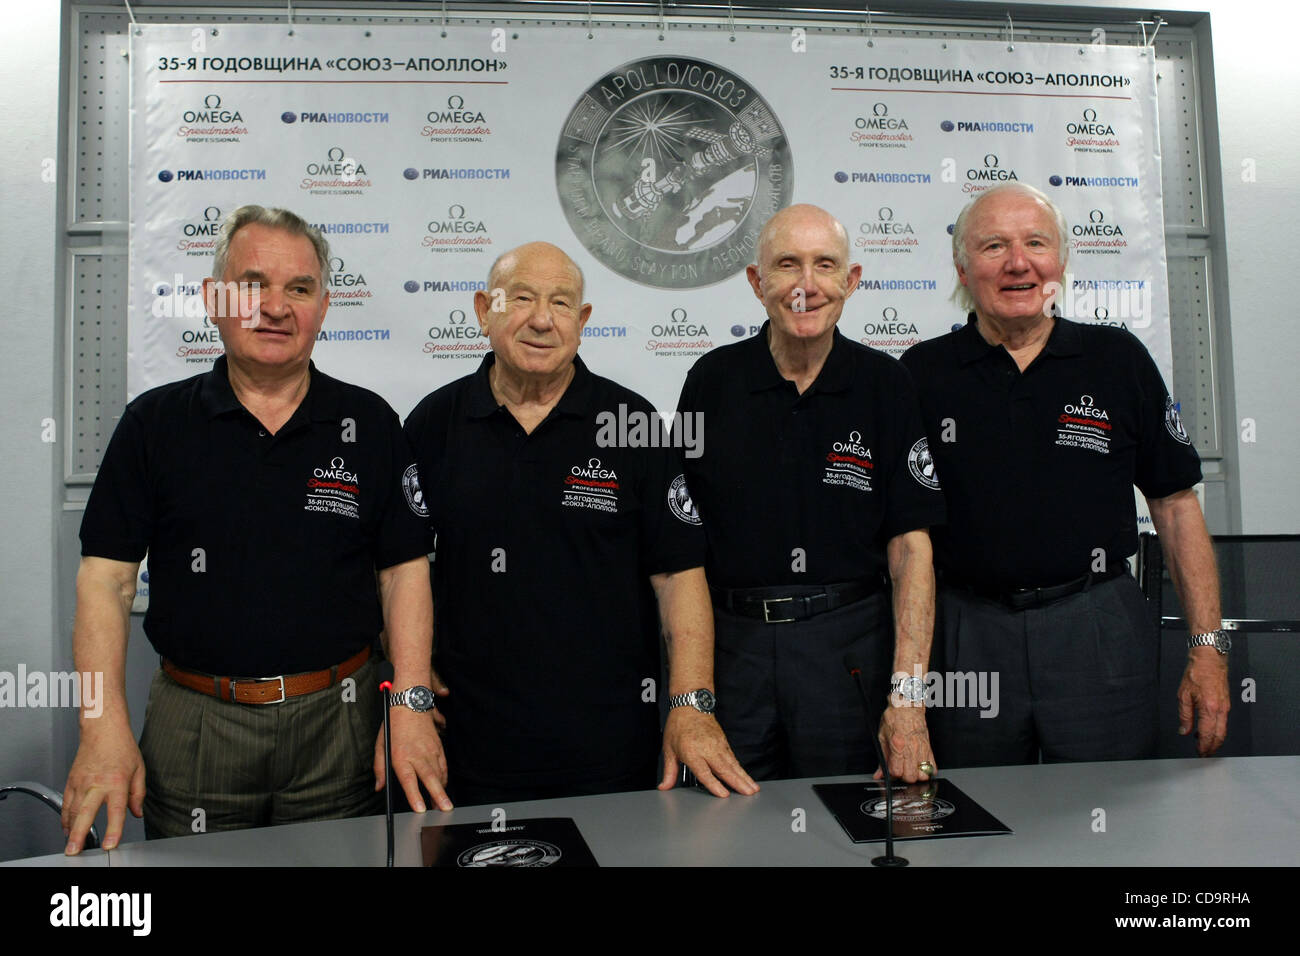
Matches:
[555,56,794,289]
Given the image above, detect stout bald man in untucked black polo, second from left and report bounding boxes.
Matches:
[406,242,758,805]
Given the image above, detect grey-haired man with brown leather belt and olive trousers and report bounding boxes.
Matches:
[64,206,451,853]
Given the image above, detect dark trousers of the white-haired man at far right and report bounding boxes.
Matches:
[927,575,1160,767]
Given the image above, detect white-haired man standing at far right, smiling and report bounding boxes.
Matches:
[904,183,1229,766]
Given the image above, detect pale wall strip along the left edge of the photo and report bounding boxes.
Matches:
[0,0,66,857]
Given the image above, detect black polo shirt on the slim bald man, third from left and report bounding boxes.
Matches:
[679,323,944,588]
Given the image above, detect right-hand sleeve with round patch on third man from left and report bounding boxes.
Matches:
[880,363,946,541]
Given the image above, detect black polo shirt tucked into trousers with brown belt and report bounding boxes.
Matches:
[81,356,428,676]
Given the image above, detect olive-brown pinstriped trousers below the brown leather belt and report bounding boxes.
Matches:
[140,658,384,839]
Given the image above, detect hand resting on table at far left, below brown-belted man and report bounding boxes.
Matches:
[62,718,144,856]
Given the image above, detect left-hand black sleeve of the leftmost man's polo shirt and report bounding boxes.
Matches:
[81,405,155,562]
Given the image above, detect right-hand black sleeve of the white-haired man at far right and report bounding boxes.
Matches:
[1130,336,1201,498]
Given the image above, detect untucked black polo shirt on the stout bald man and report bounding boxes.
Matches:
[406,352,705,787]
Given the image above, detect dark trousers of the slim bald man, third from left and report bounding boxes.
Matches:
[714,588,893,780]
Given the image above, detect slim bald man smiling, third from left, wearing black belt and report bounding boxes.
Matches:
[679,206,944,782]
